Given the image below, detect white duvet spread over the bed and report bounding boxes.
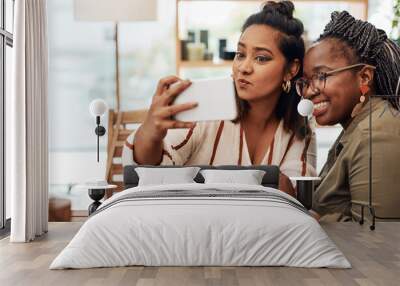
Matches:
[50,183,351,269]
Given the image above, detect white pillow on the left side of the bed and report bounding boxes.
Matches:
[135,167,200,186]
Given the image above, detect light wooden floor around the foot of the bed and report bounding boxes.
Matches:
[0,222,400,286]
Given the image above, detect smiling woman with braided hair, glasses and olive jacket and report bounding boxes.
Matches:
[296,11,400,220]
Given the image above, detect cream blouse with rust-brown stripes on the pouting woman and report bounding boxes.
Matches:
[122,120,316,179]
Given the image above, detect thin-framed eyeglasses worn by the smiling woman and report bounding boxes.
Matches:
[296,63,375,97]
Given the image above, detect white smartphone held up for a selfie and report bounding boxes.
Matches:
[173,77,238,122]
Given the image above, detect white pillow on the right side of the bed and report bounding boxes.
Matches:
[200,170,265,185]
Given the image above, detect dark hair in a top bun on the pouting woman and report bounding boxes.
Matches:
[234,1,305,139]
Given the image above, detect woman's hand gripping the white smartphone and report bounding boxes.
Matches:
[141,76,197,142]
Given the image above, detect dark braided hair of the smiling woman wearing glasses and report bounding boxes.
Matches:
[317,11,400,110]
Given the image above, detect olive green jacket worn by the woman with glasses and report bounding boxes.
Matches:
[313,98,400,220]
